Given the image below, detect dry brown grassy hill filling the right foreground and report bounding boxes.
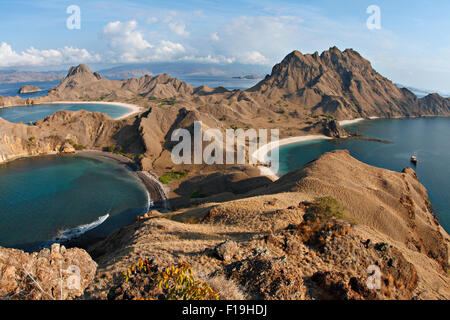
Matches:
[81,151,450,300]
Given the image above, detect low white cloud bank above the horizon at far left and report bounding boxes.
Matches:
[0,42,101,68]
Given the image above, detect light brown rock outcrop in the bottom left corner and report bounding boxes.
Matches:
[0,244,97,300]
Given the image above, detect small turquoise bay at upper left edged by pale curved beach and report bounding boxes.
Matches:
[0,103,129,123]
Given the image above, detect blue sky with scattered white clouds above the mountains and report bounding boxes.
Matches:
[0,0,450,92]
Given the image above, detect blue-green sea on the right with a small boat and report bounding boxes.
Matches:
[279,118,450,232]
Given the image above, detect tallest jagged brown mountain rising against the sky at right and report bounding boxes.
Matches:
[249,47,450,119]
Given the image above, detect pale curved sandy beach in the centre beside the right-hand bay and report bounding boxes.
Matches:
[252,134,332,180]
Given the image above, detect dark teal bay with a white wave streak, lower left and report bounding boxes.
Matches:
[0,156,149,250]
